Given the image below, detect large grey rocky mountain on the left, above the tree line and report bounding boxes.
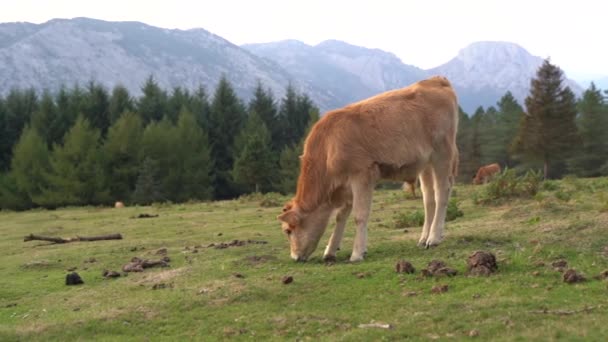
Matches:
[0,18,306,105]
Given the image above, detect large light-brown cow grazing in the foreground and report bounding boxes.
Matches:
[278,77,458,261]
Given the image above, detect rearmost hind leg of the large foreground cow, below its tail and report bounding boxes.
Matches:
[426,154,453,248]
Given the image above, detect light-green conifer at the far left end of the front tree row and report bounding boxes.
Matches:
[11,126,50,207]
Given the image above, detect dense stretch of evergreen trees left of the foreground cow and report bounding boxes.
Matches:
[0,77,319,210]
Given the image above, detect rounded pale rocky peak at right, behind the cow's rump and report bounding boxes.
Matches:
[427,42,582,113]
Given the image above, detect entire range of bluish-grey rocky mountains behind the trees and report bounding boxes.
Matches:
[0,18,582,113]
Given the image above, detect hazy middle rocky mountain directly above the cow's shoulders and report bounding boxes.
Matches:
[243,40,426,108]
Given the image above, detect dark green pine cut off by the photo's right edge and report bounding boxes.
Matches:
[571,83,608,177]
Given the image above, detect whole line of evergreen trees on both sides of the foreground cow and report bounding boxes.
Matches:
[0,60,608,210]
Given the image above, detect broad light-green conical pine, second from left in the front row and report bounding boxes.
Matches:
[37,117,109,207]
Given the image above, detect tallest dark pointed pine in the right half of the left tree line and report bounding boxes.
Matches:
[209,76,245,199]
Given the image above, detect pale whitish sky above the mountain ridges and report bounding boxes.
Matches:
[0,0,608,80]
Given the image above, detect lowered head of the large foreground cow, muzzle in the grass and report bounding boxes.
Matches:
[277,201,331,261]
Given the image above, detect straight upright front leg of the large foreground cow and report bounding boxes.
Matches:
[350,180,374,262]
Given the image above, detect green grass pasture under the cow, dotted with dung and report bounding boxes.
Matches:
[0,178,608,341]
